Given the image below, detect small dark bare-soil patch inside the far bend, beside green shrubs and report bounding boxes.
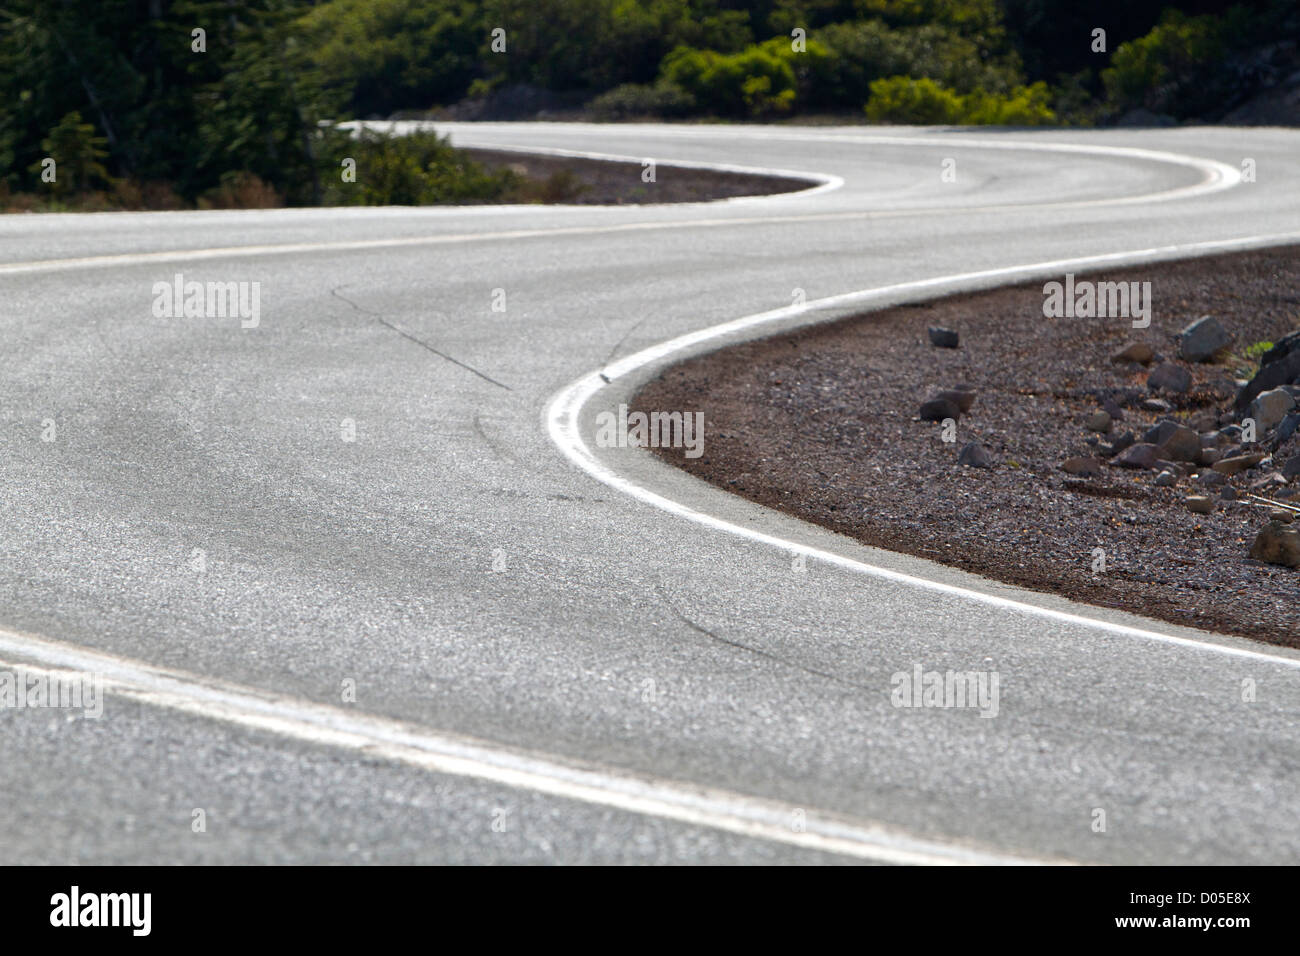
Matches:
[462,150,815,206]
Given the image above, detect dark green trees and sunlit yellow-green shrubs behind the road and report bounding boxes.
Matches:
[0,0,1300,211]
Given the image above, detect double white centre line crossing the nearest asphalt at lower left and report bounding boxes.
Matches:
[0,631,1045,865]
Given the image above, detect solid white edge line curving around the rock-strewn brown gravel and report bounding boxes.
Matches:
[546,233,1300,669]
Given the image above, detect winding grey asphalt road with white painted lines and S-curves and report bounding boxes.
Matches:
[0,124,1300,864]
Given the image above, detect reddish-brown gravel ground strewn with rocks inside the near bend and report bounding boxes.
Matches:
[636,246,1300,646]
